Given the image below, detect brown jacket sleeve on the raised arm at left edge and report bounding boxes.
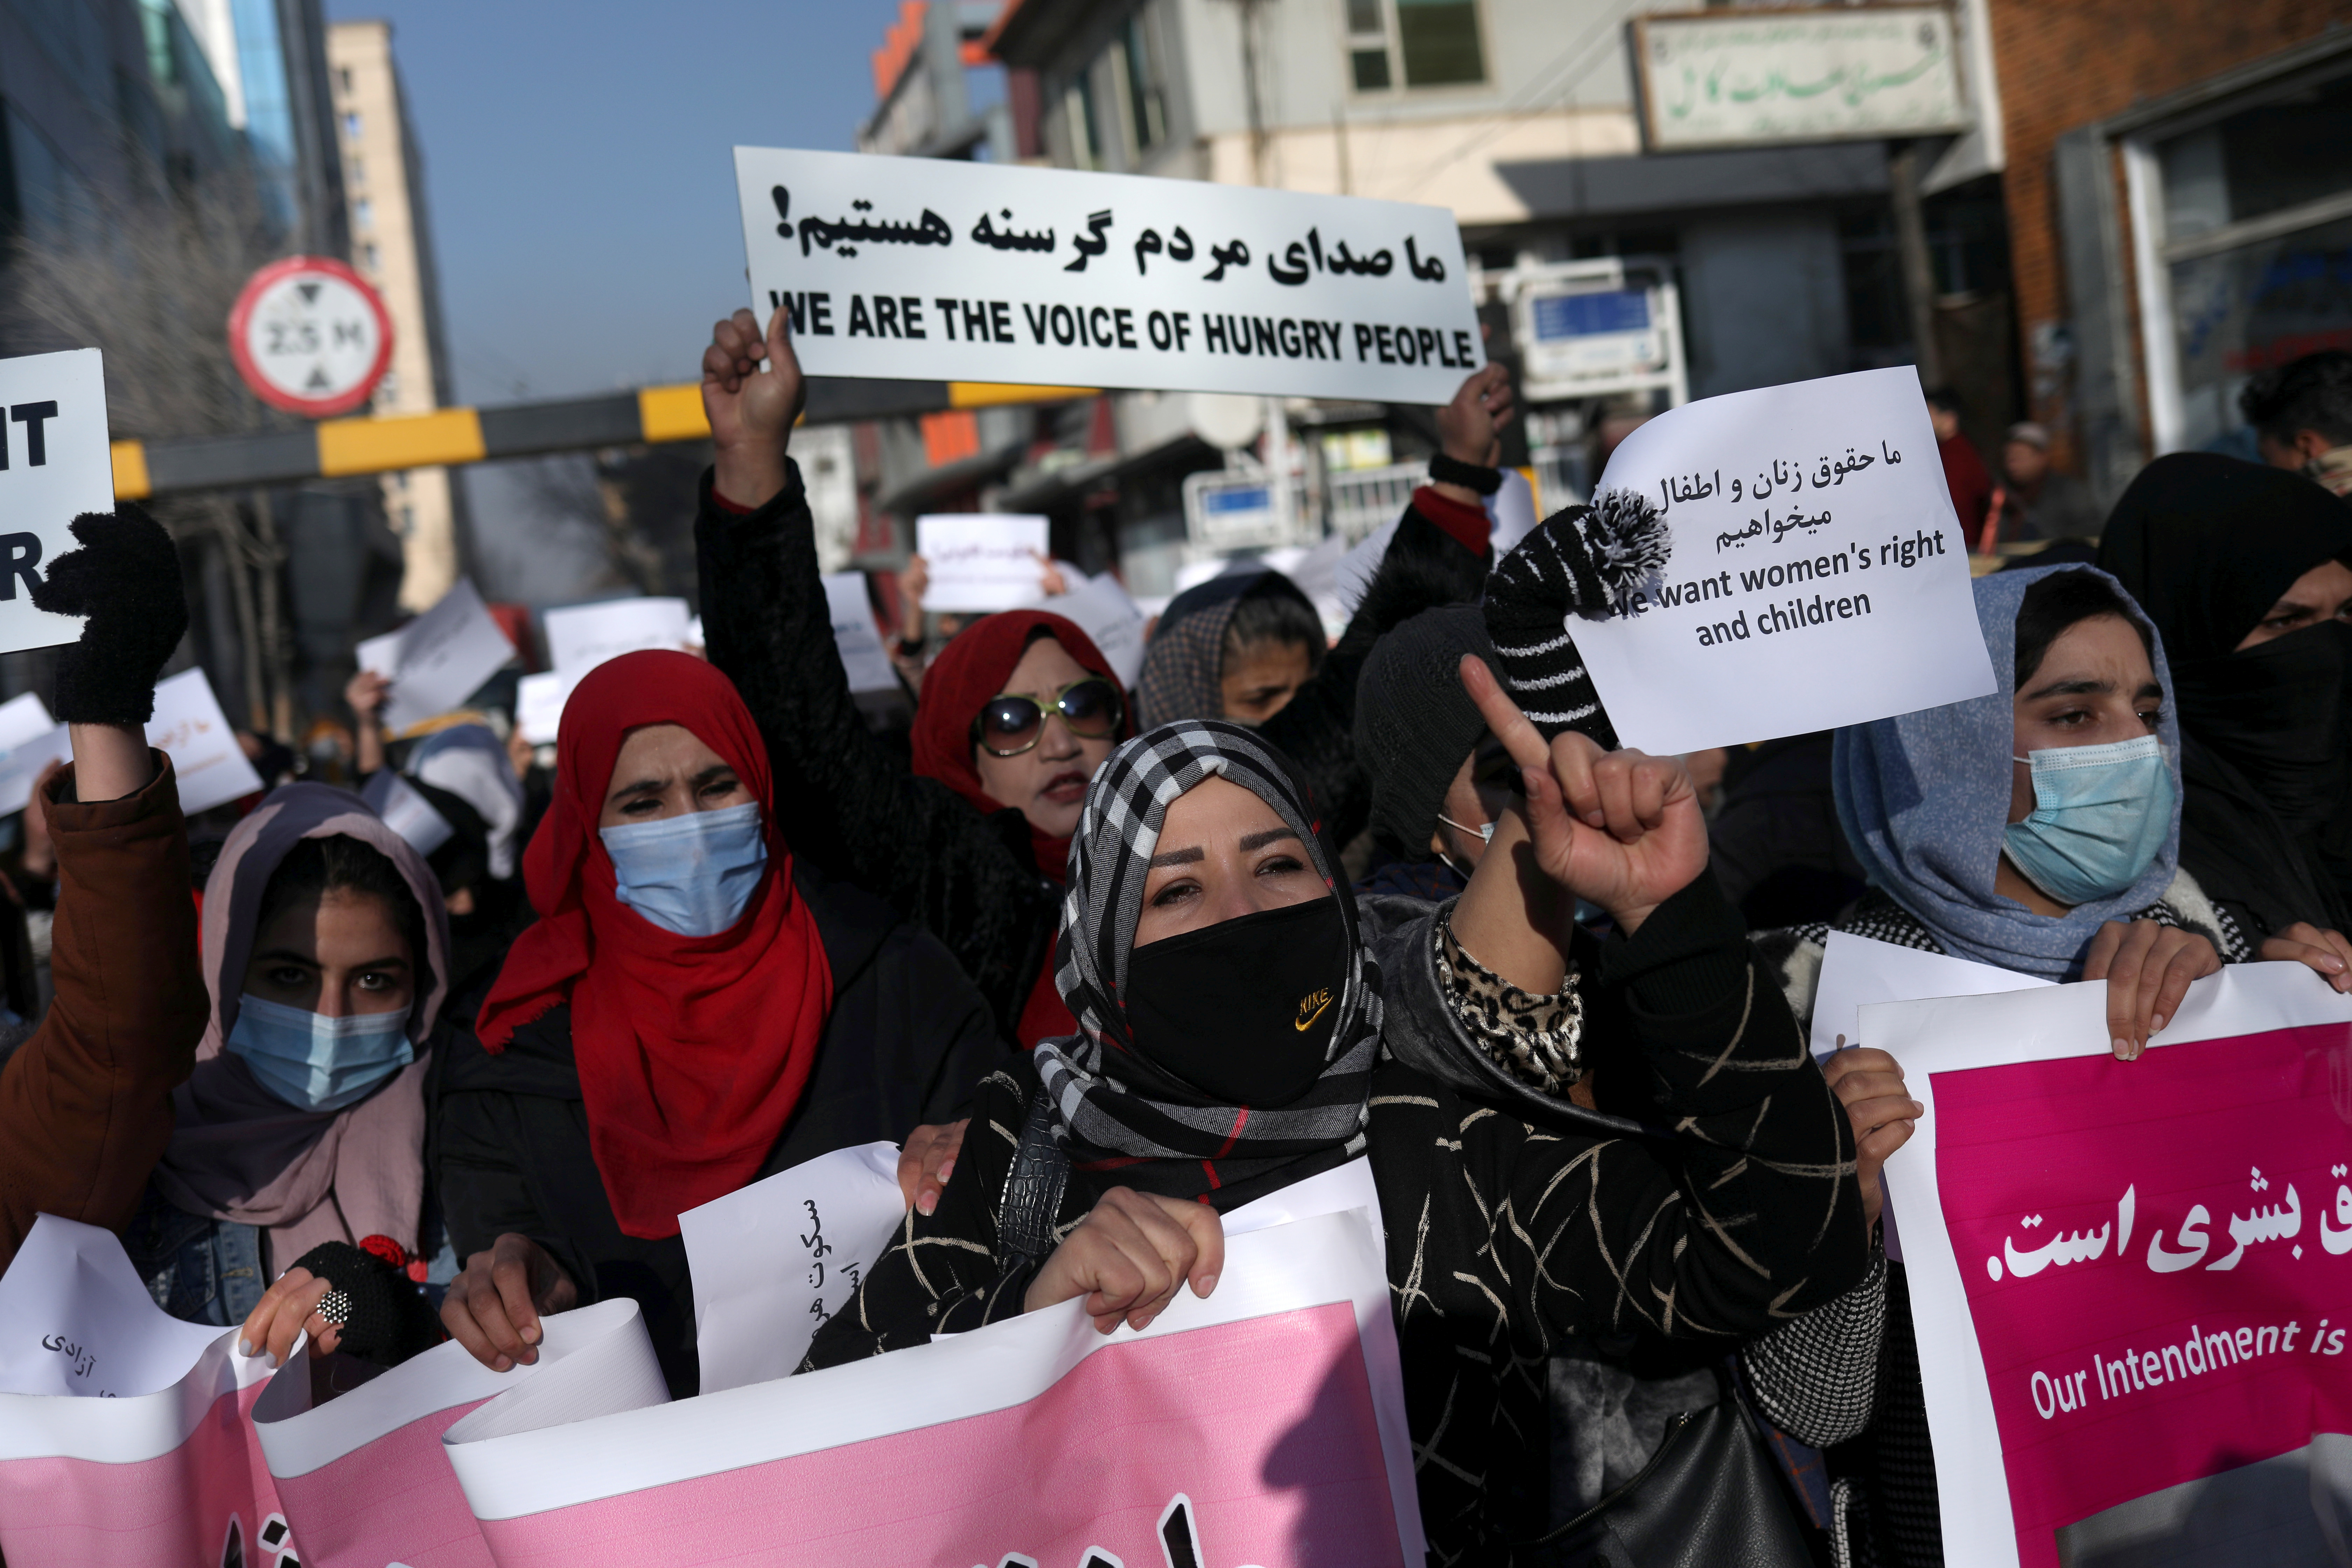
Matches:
[0,752,207,1267]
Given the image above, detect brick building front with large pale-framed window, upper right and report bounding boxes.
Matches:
[1992,0,2352,501]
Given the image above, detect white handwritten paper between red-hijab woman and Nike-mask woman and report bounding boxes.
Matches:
[677,1142,905,1394]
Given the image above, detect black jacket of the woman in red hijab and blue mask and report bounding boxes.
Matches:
[428,870,1004,1399]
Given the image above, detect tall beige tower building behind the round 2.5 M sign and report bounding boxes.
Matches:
[327,21,461,611]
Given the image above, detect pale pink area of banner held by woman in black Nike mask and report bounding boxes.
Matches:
[482,1302,1404,1568]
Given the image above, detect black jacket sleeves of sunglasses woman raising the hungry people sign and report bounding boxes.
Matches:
[694,463,1484,1039]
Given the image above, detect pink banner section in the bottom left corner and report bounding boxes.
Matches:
[0,1382,294,1568]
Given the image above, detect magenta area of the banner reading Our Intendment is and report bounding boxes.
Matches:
[1928,1011,2352,1568]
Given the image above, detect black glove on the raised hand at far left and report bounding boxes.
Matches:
[33,501,188,724]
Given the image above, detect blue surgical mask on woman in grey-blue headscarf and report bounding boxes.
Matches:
[2006,736,2173,905]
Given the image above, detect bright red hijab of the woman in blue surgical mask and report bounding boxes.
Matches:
[480,651,833,1237]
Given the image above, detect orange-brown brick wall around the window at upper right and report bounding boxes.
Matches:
[1992,0,2352,468]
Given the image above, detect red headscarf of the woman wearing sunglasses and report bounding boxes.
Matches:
[910,609,1136,1046]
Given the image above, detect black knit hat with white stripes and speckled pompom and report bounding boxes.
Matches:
[1486,489,1672,750]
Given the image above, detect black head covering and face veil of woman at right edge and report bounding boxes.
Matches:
[2098,451,2352,940]
